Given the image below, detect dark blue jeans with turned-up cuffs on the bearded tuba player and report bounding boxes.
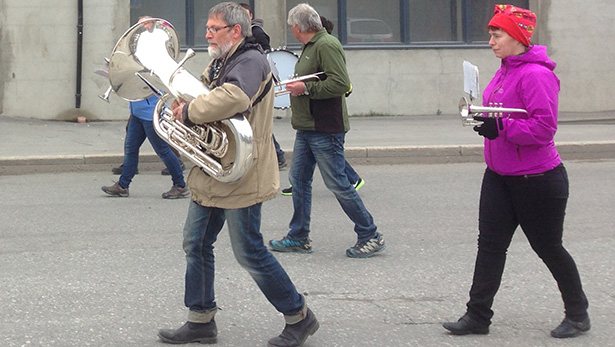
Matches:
[183,201,304,315]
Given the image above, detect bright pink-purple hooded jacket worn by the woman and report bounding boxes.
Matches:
[483,45,561,176]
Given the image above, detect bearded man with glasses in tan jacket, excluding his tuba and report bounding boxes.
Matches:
[158,2,319,346]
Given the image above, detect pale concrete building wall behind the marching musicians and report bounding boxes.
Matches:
[0,0,615,120]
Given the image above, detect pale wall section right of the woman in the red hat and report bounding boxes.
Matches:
[541,0,615,112]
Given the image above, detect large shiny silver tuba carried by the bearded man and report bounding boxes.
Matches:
[101,18,254,183]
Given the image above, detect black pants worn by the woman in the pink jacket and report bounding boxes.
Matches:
[467,164,588,324]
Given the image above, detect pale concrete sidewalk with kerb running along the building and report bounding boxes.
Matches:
[0,111,615,174]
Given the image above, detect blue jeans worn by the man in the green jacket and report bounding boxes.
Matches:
[287,130,377,241]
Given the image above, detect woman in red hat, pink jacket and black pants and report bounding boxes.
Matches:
[443,5,590,338]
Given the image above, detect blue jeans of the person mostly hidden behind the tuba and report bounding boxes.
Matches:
[118,116,186,188]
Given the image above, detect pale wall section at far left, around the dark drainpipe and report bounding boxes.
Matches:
[0,0,129,120]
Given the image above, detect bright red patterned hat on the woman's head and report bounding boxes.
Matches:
[489,5,536,46]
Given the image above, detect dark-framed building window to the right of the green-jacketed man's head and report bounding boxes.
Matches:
[286,0,529,48]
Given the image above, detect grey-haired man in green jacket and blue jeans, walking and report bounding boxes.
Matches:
[269,4,385,258]
